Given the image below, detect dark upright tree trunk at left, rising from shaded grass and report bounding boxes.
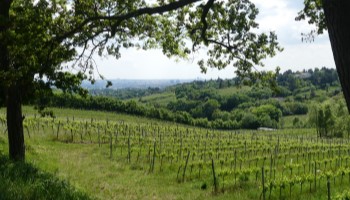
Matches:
[0,0,25,160]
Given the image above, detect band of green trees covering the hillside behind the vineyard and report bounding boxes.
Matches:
[18,68,340,129]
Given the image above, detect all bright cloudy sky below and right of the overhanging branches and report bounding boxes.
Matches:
[96,0,335,79]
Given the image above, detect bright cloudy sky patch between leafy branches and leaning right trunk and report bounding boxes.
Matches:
[252,0,335,70]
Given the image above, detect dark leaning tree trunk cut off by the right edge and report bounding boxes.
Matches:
[323,0,350,113]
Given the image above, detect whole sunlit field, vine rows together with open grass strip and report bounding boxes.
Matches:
[0,107,350,199]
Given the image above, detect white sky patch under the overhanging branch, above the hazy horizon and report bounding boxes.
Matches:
[96,49,234,79]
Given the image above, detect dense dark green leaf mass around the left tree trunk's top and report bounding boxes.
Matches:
[0,1,86,108]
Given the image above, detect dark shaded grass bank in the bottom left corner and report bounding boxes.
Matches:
[0,152,90,200]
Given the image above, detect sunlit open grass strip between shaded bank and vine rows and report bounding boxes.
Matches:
[0,129,221,199]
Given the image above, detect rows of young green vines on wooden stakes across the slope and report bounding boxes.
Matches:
[0,109,350,199]
